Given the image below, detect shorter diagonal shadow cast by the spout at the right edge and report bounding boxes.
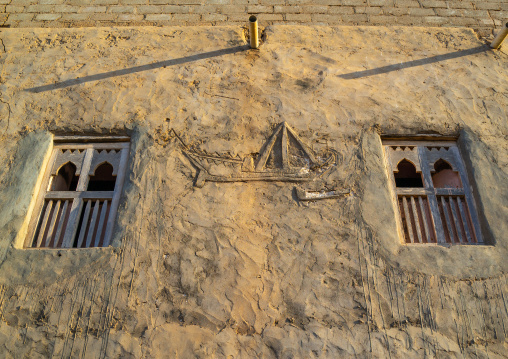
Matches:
[339,45,490,80]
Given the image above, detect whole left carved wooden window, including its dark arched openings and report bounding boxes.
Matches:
[25,137,129,248]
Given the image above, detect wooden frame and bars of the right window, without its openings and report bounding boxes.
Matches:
[382,138,485,245]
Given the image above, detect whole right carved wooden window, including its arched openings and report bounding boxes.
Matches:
[383,140,483,244]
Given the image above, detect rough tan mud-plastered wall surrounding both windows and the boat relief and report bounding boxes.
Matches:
[0,27,508,358]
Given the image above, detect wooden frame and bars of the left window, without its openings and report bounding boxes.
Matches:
[23,136,130,250]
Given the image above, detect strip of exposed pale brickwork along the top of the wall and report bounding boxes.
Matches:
[0,0,508,35]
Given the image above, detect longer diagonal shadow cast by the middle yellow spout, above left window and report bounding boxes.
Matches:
[24,45,250,93]
